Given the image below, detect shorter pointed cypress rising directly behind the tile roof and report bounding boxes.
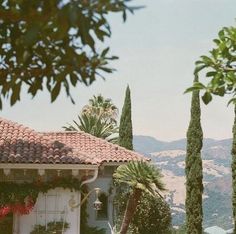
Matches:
[118,86,133,150]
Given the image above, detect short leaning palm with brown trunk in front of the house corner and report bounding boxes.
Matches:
[113,161,165,234]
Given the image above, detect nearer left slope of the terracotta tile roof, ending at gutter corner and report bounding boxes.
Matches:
[0,118,92,164]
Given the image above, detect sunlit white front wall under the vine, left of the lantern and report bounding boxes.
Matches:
[14,188,79,234]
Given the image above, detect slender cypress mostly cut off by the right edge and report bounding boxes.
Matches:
[231,105,236,233]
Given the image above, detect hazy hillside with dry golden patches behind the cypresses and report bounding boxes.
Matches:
[134,136,232,228]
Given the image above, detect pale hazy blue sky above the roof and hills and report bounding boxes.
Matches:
[1,0,236,141]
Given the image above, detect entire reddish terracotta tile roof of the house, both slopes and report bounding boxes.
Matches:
[0,118,145,165]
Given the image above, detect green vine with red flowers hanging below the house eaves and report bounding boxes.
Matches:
[0,176,81,218]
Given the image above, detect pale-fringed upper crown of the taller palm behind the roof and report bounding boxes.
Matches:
[82,94,118,123]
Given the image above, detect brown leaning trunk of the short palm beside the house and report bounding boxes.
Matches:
[120,189,142,234]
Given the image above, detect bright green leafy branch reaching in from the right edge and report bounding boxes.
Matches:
[186,27,236,104]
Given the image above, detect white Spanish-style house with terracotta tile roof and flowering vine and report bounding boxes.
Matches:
[0,118,145,234]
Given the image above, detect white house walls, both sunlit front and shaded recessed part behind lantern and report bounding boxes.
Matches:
[14,167,113,234]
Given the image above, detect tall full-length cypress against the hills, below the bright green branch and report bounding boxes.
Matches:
[185,77,203,234]
